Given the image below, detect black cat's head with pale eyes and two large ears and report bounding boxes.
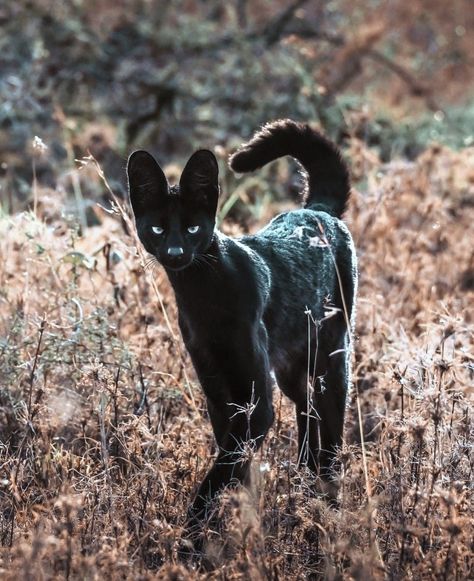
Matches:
[127,149,219,270]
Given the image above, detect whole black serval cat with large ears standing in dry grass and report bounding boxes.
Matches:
[128,120,357,523]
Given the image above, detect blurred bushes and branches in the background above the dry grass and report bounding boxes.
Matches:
[0,0,474,224]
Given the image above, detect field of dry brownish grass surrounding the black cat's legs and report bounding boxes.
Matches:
[0,142,474,581]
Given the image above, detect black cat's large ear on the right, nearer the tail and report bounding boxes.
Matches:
[179,149,219,212]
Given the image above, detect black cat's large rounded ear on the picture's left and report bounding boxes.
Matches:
[127,150,169,218]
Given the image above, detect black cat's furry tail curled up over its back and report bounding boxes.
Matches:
[229,119,351,218]
